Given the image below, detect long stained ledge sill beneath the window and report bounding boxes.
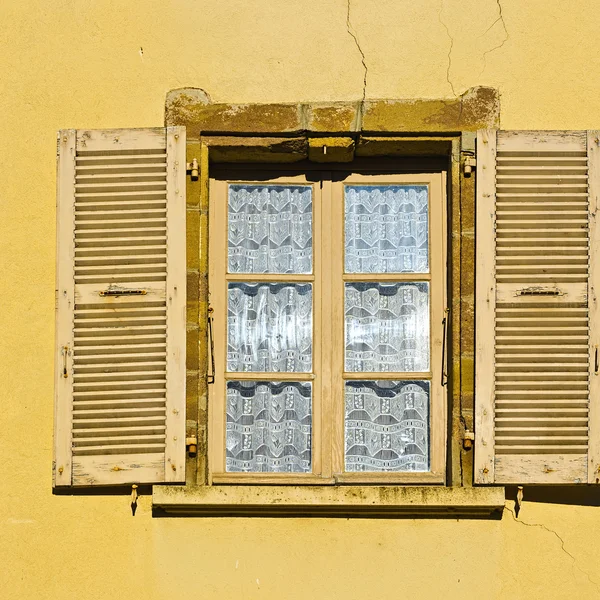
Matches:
[152,485,504,519]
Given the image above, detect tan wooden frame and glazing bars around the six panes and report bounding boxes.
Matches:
[208,165,448,485]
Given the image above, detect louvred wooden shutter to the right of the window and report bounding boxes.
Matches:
[475,130,600,483]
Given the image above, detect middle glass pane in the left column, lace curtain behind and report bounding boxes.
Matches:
[227,283,312,373]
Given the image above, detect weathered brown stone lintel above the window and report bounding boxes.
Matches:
[165,87,500,136]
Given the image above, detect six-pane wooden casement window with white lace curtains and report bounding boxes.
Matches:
[209,171,446,484]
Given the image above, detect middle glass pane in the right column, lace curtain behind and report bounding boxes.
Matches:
[345,282,429,372]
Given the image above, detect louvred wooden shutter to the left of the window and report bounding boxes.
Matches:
[54,127,186,487]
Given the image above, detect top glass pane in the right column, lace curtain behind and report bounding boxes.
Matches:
[344,185,429,273]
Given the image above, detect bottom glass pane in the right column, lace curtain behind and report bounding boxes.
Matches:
[344,381,429,472]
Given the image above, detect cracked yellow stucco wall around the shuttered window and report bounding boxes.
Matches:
[0,0,600,600]
